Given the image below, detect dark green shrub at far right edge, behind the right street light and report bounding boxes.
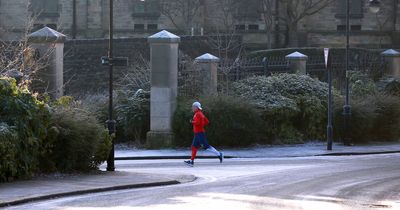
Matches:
[334,93,400,143]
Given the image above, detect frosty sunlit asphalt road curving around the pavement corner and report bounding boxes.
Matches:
[3,154,400,210]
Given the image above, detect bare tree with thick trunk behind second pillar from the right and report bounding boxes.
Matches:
[279,0,334,47]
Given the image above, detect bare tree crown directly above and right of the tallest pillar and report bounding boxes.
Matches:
[160,0,203,33]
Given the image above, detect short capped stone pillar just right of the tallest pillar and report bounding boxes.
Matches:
[195,53,219,95]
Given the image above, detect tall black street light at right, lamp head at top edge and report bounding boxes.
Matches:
[343,0,381,146]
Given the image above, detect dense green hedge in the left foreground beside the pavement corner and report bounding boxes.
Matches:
[0,77,111,182]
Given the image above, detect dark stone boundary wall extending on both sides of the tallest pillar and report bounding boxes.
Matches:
[64,36,234,95]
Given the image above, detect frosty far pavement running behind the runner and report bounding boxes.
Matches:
[115,142,400,160]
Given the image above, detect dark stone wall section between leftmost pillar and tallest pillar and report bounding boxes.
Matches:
[64,39,149,95]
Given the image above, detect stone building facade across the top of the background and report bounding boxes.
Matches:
[0,0,400,46]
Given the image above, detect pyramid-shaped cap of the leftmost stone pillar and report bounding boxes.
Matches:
[28,27,67,43]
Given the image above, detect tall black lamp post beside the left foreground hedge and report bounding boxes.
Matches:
[107,0,116,171]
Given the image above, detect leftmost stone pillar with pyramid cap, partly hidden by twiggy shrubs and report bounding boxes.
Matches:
[28,27,66,99]
